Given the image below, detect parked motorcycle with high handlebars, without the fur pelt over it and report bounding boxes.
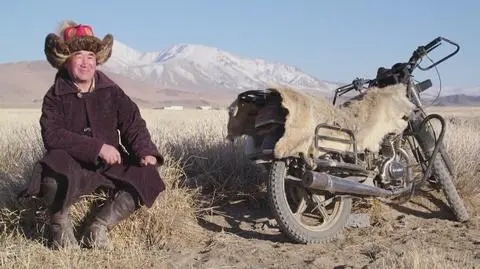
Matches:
[229,37,469,243]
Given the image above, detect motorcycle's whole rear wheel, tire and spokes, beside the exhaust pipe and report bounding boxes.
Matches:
[267,160,352,244]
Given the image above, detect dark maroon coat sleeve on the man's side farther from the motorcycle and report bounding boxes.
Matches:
[40,92,103,164]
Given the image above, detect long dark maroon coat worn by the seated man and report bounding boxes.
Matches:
[23,70,165,207]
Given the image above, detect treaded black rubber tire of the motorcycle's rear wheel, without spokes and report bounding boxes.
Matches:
[267,161,352,244]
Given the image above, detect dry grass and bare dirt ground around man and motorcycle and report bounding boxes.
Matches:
[0,105,480,269]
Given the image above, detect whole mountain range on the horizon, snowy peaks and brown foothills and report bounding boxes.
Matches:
[0,41,480,107]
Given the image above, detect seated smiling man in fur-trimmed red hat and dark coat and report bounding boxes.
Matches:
[19,21,165,248]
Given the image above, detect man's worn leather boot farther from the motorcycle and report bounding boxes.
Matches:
[41,176,79,249]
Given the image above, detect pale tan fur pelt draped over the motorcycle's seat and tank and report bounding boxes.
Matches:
[228,84,414,164]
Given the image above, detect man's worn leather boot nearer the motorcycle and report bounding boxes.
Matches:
[82,190,136,249]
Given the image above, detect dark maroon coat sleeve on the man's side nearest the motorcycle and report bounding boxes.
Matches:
[117,88,164,165]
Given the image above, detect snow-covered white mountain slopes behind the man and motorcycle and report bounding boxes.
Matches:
[101,41,335,93]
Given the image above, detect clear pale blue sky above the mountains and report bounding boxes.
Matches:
[0,0,480,87]
